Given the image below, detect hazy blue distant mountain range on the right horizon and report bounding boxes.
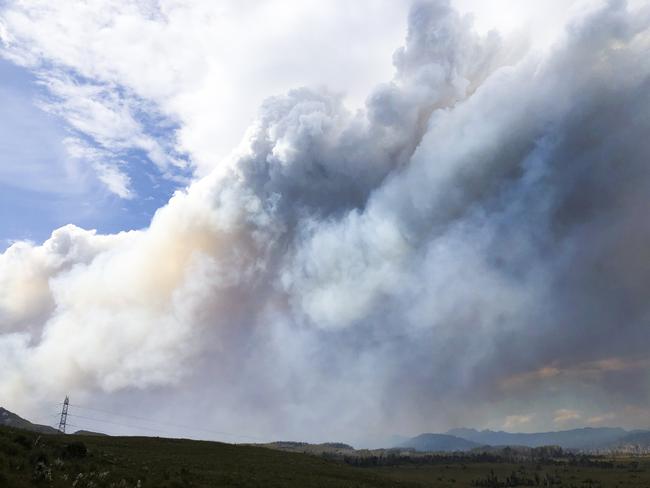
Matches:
[394,427,650,452]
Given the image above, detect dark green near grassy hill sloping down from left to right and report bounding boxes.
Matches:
[0,427,420,488]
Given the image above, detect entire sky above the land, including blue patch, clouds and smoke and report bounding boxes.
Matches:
[0,0,650,446]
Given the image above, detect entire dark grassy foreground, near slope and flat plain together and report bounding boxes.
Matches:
[0,427,650,488]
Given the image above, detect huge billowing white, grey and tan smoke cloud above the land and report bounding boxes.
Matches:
[0,1,650,441]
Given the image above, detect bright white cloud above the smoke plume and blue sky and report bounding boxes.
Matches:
[0,0,410,181]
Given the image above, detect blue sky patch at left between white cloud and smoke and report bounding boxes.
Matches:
[0,59,191,250]
